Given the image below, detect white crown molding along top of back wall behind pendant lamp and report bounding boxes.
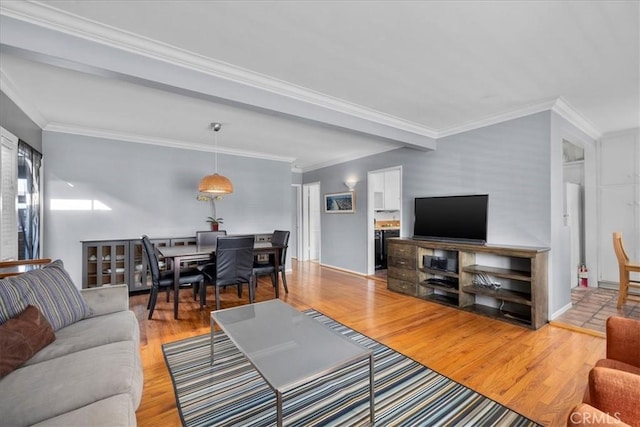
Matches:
[42,123,295,163]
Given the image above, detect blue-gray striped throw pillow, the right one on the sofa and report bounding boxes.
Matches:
[17,260,91,331]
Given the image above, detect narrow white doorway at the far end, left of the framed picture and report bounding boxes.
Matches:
[298,182,320,261]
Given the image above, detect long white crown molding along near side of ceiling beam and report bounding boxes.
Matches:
[0,1,437,138]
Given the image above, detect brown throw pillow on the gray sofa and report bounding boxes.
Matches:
[0,305,56,377]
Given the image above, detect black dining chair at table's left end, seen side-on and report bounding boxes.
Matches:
[141,235,204,320]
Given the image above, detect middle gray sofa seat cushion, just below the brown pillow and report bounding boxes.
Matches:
[0,341,142,427]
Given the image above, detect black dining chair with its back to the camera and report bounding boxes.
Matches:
[200,236,255,310]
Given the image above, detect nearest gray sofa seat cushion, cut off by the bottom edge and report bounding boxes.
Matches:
[32,394,136,427]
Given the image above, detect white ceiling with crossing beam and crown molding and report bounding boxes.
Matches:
[0,0,640,170]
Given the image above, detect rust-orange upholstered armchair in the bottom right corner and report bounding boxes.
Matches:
[567,316,640,427]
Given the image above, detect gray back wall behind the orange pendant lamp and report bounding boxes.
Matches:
[43,132,291,286]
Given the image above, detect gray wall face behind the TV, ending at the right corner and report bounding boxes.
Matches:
[304,112,551,274]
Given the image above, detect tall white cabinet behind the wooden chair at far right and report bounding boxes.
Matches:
[598,129,640,286]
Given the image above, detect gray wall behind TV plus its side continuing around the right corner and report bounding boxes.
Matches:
[303,111,597,318]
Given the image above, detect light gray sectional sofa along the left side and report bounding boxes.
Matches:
[0,261,143,427]
